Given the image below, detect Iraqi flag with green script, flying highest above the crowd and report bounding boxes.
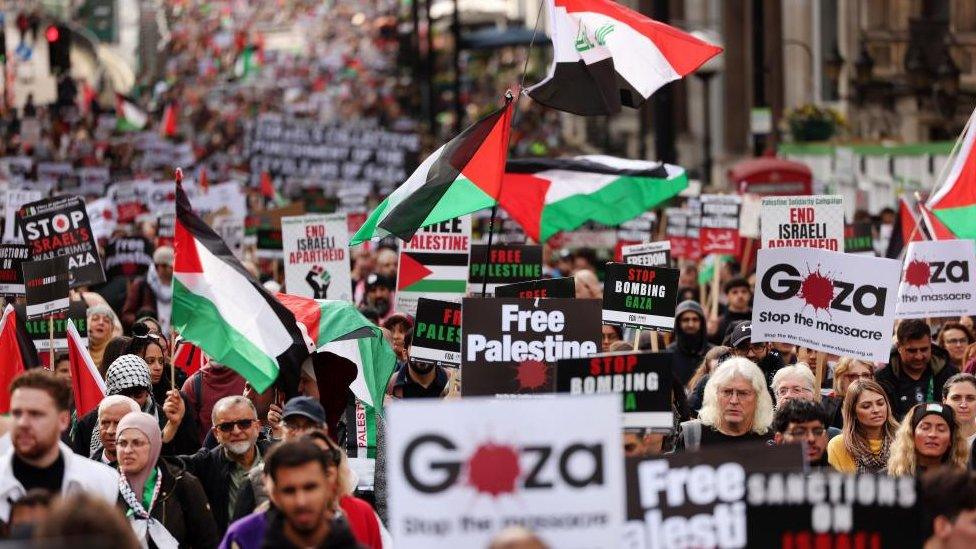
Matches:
[528,0,722,115]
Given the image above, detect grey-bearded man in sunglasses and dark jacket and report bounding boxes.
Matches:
[180,395,269,535]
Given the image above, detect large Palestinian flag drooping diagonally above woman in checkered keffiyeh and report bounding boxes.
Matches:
[172,184,309,397]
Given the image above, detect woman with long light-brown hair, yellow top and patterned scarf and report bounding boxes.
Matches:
[827,379,898,473]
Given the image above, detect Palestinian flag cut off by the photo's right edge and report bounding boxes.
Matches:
[925,106,976,239]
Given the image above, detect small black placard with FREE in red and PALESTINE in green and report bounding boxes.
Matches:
[468,244,542,295]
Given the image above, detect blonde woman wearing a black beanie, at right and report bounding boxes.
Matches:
[888,403,969,476]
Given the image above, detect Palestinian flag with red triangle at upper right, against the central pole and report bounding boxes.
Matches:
[350,100,512,246]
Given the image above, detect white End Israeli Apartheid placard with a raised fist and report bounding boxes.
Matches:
[281,214,352,301]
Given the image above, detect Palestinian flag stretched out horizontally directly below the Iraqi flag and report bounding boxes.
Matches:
[499,155,688,242]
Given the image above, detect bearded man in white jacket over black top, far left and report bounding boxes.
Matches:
[0,368,119,521]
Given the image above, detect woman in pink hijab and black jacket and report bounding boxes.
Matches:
[116,412,220,549]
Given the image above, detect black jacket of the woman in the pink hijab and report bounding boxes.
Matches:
[119,460,220,549]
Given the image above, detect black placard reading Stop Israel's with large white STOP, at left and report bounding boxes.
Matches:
[17,196,105,288]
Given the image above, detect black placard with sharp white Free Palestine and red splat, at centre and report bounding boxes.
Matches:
[461,297,601,396]
